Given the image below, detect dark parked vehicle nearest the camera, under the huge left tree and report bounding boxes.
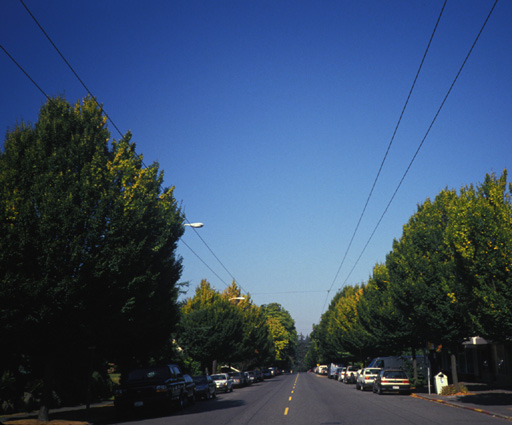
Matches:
[114,365,187,412]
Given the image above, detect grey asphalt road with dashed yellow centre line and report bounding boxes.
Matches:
[97,373,508,425]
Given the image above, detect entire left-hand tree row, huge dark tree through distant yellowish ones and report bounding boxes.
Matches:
[0,98,296,421]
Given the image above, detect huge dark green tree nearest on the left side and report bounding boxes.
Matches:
[0,98,183,420]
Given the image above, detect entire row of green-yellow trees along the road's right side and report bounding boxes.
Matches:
[308,170,512,383]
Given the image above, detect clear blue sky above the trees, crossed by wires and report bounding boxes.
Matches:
[0,0,512,334]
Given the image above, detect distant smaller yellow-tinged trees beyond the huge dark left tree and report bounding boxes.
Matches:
[176,280,297,373]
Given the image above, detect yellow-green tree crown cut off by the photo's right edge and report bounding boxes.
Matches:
[447,170,512,341]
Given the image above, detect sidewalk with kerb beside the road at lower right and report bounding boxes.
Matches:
[412,383,512,421]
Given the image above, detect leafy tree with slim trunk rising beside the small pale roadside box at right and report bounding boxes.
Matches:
[386,190,474,383]
